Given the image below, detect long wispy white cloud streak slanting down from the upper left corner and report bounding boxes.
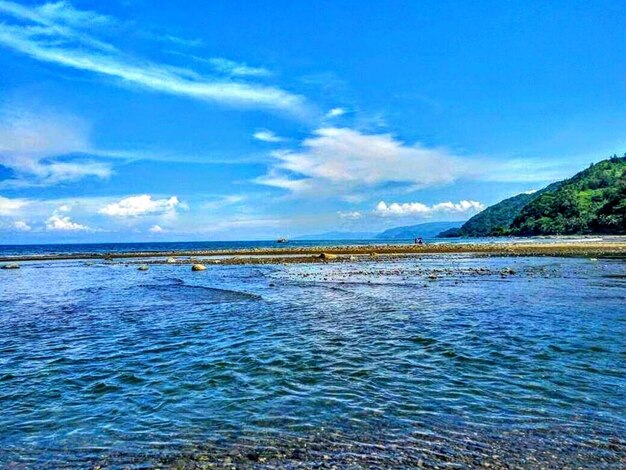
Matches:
[0,1,306,115]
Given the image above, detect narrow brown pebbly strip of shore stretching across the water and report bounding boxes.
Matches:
[0,239,626,264]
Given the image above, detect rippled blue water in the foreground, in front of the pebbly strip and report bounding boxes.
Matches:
[0,256,626,468]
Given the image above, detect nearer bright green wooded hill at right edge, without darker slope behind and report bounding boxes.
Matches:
[509,156,626,235]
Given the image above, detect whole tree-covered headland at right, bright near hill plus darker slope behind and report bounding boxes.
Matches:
[440,154,626,237]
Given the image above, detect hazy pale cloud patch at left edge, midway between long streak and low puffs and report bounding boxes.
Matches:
[0,105,111,186]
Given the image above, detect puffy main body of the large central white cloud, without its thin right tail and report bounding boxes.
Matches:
[257,127,469,196]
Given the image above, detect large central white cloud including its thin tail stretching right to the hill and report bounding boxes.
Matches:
[255,127,584,201]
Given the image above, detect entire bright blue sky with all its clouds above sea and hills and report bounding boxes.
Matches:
[0,0,626,243]
